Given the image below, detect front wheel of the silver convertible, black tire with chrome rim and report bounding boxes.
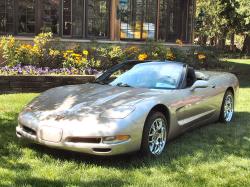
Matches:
[141,112,168,156]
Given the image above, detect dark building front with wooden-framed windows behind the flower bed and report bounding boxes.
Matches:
[0,0,195,43]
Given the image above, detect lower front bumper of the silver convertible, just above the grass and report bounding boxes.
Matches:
[16,125,138,156]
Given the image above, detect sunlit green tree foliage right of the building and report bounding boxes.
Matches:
[196,0,250,49]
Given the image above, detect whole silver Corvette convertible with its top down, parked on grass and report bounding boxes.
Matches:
[16,61,239,156]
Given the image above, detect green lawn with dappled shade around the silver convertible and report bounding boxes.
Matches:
[0,60,250,187]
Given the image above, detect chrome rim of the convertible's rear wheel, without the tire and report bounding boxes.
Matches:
[224,94,234,122]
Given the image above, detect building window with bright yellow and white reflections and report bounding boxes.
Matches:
[120,0,157,40]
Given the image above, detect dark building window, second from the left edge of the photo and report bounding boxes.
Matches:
[18,0,35,33]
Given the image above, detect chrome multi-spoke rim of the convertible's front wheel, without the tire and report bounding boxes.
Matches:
[148,118,167,155]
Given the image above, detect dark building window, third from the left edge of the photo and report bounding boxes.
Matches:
[41,0,60,35]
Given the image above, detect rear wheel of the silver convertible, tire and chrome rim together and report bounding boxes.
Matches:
[220,90,234,123]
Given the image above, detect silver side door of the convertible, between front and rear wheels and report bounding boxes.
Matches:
[176,69,218,129]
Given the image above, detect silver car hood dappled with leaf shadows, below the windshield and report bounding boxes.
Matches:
[24,84,164,119]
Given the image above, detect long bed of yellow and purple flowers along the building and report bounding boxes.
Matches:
[0,33,225,75]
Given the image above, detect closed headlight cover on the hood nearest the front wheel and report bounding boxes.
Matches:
[101,106,135,119]
